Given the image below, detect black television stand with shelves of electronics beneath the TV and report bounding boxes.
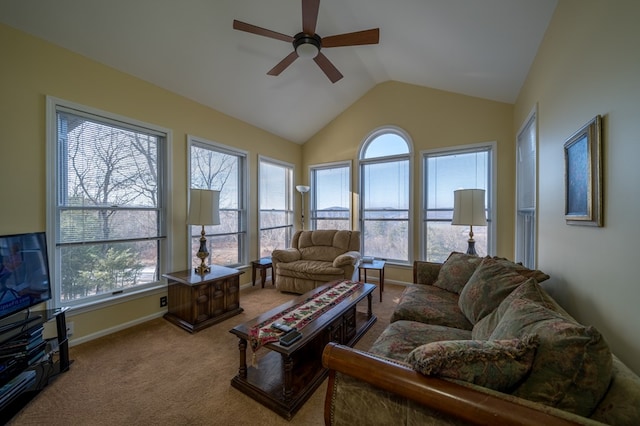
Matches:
[0,308,71,421]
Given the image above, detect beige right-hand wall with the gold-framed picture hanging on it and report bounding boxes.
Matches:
[514,0,640,372]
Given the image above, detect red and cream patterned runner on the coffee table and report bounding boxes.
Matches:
[249,281,363,356]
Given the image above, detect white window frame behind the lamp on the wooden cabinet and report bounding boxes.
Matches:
[185,135,250,268]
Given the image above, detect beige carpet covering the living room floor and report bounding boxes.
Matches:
[9,282,404,426]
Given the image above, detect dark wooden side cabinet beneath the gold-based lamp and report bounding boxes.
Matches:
[163,265,243,333]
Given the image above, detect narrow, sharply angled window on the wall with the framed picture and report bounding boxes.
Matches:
[516,112,537,269]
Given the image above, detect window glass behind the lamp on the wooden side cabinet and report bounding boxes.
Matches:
[188,136,247,267]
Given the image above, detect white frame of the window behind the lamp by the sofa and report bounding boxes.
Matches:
[419,141,497,260]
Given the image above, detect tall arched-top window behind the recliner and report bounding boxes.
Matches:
[360,127,412,264]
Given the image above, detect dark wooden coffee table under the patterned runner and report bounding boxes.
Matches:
[230,283,377,420]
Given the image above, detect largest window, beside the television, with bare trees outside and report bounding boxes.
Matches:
[47,98,167,306]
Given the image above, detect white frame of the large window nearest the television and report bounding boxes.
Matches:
[45,96,173,313]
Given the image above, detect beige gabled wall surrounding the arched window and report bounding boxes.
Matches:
[303,81,515,282]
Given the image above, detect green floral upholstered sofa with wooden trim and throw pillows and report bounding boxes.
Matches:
[323,253,640,425]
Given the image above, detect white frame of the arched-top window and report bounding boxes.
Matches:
[357,125,414,266]
